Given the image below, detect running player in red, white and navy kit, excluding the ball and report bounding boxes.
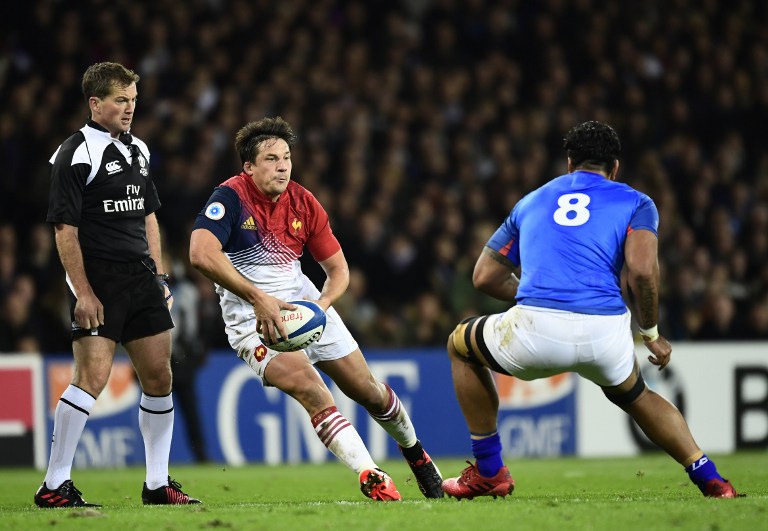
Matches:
[190,117,443,501]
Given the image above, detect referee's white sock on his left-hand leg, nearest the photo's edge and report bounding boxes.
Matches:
[45,384,96,490]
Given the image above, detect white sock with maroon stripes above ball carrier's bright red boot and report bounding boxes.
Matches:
[312,406,378,475]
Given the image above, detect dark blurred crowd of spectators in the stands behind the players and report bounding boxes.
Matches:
[0,0,768,358]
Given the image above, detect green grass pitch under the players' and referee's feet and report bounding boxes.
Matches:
[0,451,768,531]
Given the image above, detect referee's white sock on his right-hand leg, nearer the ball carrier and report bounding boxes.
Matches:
[139,393,173,490]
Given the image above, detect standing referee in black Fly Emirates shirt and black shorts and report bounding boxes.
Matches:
[34,62,200,508]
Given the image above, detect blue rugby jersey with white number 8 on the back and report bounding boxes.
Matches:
[486,171,659,315]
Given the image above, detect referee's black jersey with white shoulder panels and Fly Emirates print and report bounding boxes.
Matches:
[46,120,160,262]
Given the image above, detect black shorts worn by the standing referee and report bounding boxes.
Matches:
[68,258,173,343]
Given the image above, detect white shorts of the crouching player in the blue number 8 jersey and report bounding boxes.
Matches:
[482,305,635,387]
